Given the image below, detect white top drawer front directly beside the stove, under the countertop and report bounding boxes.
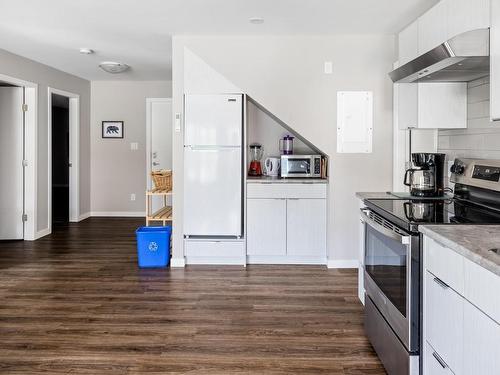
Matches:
[424,236,464,295]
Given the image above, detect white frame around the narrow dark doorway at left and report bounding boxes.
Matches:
[47,87,80,233]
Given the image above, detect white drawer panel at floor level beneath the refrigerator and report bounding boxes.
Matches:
[184,240,245,257]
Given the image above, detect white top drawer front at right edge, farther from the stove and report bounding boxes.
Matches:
[464,258,500,324]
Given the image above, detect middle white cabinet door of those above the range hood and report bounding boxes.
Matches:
[418,1,448,55]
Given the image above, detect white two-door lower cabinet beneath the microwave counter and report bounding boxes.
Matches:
[247,183,327,264]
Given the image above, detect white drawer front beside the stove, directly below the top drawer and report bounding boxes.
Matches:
[424,271,464,373]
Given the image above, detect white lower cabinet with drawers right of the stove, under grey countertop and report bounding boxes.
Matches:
[422,236,500,375]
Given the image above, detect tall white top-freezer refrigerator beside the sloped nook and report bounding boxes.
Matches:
[184,94,243,237]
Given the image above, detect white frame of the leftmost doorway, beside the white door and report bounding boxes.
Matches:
[0,74,37,241]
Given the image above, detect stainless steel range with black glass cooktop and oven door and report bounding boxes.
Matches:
[361,159,500,375]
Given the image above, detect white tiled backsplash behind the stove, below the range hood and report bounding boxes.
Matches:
[438,78,500,160]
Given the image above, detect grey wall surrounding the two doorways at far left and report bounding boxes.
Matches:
[0,50,90,232]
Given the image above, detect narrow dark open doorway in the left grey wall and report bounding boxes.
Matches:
[50,93,70,226]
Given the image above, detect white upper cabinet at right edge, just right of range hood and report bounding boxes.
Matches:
[490,1,500,121]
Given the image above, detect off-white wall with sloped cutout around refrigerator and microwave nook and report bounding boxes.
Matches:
[173,35,394,260]
